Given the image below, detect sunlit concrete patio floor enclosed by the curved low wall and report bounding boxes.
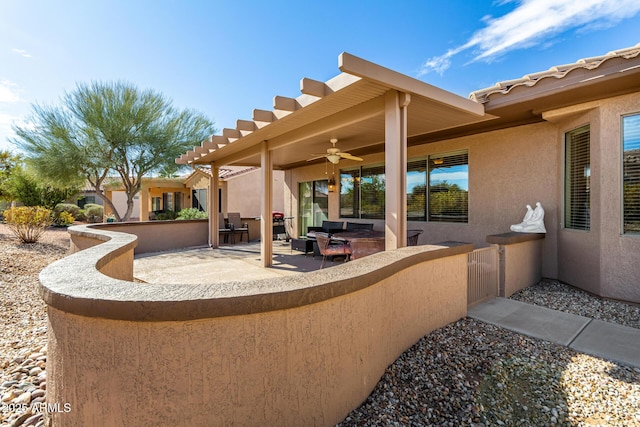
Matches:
[133,240,343,284]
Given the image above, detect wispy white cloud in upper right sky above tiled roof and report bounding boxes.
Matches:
[420,0,640,76]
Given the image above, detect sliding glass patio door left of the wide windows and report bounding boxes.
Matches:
[298,179,329,235]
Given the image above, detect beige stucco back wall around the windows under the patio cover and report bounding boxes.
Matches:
[285,123,560,277]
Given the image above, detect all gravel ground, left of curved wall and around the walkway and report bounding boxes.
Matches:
[0,224,640,426]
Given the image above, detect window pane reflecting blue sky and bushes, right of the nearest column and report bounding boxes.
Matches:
[428,151,469,223]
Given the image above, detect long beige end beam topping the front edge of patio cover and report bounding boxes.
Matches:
[338,52,484,116]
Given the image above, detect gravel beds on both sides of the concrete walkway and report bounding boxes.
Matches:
[338,280,640,427]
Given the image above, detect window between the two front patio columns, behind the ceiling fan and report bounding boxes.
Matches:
[340,165,386,219]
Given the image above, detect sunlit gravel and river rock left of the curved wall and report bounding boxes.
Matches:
[0,224,69,426]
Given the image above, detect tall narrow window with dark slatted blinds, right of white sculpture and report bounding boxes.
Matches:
[564,125,591,230]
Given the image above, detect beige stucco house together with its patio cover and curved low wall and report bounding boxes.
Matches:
[40,44,640,425]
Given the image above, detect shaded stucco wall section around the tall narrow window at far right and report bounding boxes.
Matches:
[546,94,640,302]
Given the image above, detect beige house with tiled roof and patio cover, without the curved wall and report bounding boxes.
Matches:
[176,44,640,302]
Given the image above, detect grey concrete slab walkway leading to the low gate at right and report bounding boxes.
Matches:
[467,298,640,368]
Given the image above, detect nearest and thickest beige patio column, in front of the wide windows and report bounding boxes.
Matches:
[384,90,411,250]
